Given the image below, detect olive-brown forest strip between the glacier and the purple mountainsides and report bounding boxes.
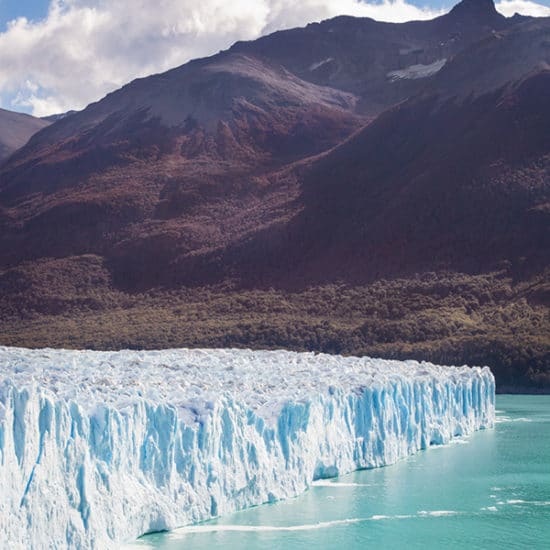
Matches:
[0,256,550,391]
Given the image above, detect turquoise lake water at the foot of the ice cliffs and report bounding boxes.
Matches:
[135,395,550,550]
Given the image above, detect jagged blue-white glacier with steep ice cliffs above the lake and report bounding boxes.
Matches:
[0,347,495,550]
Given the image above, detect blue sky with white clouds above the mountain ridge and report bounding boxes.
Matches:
[0,0,550,116]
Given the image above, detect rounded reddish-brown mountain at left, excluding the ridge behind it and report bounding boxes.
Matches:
[0,54,365,274]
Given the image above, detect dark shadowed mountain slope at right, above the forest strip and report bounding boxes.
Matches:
[244,17,550,280]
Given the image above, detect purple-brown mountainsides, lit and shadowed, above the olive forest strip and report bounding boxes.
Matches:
[0,0,550,383]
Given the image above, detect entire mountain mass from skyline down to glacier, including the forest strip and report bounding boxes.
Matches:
[0,0,550,391]
